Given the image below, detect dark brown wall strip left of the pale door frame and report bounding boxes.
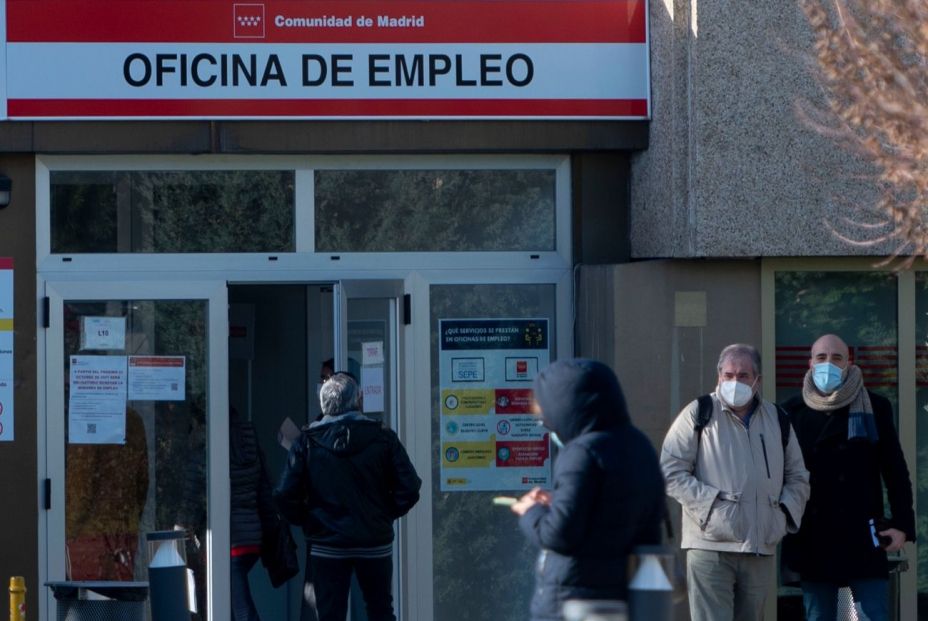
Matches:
[0,155,37,614]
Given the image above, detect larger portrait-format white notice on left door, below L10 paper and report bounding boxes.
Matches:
[68,356,126,444]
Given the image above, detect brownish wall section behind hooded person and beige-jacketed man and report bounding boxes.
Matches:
[576,261,764,621]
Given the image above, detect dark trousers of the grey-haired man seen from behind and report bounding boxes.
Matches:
[310,556,396,621]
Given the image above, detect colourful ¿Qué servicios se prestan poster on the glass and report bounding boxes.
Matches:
[439,319,551,492]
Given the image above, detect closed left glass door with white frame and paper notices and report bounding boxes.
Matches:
[43,281,229,620]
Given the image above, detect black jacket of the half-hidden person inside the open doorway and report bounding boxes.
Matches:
[229,413,277,548]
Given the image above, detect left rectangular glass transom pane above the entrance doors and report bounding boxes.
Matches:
[51,170,296,253]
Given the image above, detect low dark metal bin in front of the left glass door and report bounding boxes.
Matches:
[45,581,148,621]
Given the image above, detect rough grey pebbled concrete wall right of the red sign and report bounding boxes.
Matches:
[631,0,895,258]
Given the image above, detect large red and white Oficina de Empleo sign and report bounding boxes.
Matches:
[0,0,650,120]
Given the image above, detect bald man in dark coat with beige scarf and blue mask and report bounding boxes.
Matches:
[783,334,915,621]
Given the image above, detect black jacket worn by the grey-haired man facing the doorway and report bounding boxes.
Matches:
[274,412,422,548]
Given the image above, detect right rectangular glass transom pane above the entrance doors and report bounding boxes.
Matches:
[315,170,555,252]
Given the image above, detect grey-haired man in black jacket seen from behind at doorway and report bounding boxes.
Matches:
[274,373,422,621]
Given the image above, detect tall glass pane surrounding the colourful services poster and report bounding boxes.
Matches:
[430,285,556,621]
